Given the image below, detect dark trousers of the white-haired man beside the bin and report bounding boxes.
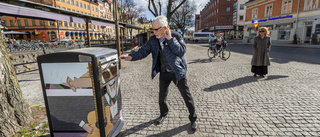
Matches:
[159,72,197,122]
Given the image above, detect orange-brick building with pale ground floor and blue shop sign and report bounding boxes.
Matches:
[244,0,320,43]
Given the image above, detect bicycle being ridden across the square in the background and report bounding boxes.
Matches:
[207,41,231,60]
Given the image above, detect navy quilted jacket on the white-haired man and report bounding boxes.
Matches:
[129,31,187,81]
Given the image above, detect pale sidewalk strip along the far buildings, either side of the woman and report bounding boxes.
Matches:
[227,40,320,48]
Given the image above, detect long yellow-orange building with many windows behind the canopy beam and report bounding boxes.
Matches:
[1,0,112,41]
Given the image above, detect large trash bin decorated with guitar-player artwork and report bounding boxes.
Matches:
[38,48,124,137]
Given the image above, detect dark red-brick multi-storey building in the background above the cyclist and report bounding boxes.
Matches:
[200,0,234,37]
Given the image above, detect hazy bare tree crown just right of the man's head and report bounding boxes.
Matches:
[169,1,197,34]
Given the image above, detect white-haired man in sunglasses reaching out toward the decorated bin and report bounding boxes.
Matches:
[120,16,198,131]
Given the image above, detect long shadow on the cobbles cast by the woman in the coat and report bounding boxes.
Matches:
[203,75,288,92]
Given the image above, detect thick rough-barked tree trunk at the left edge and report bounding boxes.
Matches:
[0,34,32,137]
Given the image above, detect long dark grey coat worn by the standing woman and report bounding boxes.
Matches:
[251,36,271,66]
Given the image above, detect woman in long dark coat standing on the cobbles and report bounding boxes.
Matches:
[251,27,271,77]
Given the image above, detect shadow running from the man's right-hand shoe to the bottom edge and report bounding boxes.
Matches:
[147,123,194,137]
